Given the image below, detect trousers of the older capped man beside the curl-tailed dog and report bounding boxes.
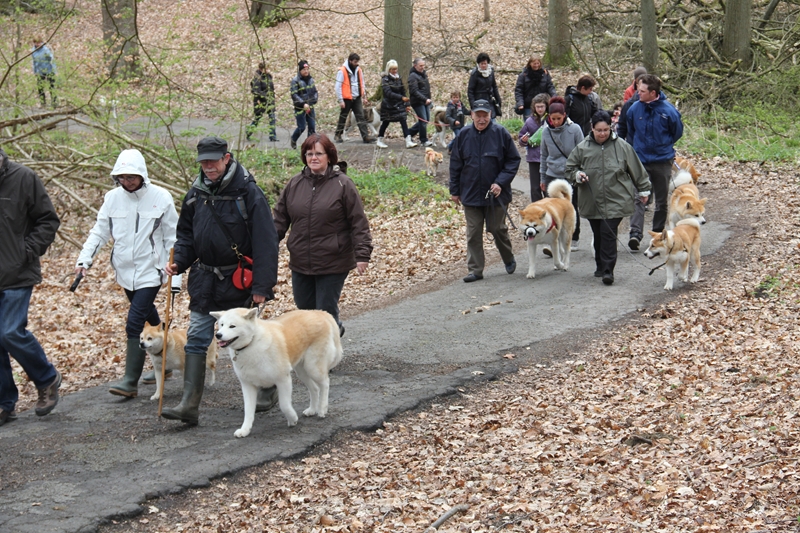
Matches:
[464,205,514,276]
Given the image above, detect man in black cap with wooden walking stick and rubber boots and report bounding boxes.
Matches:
[161,137,278,426]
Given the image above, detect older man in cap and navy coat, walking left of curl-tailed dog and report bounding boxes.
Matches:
[450,100,521,283]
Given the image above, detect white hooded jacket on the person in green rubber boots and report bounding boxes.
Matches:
[77,150,180,291]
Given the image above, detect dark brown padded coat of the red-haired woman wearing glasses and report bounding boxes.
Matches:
[272,166,372,276]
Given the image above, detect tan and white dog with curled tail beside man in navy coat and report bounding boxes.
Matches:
[519,179,575,279]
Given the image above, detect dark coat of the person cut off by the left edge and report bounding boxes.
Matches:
[0,149,60,291]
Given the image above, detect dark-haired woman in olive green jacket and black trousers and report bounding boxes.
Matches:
[566,111,651,285]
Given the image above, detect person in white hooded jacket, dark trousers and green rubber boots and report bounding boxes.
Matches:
[75,150,180,398]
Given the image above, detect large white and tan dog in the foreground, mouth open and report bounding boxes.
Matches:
[211,308,342,437]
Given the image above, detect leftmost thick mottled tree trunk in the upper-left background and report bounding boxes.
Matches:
[100,0,140,77]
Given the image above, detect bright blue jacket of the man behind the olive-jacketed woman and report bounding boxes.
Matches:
[626,92,683,165]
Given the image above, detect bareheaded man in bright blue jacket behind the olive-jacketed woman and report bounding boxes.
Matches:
[626,74,683,250]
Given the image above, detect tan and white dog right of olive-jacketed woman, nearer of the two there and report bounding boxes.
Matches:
[644,218,700,291]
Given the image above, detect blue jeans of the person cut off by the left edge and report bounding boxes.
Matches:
[0,286,56,412]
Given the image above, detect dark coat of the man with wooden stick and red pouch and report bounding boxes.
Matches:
[174,158,278,313]
